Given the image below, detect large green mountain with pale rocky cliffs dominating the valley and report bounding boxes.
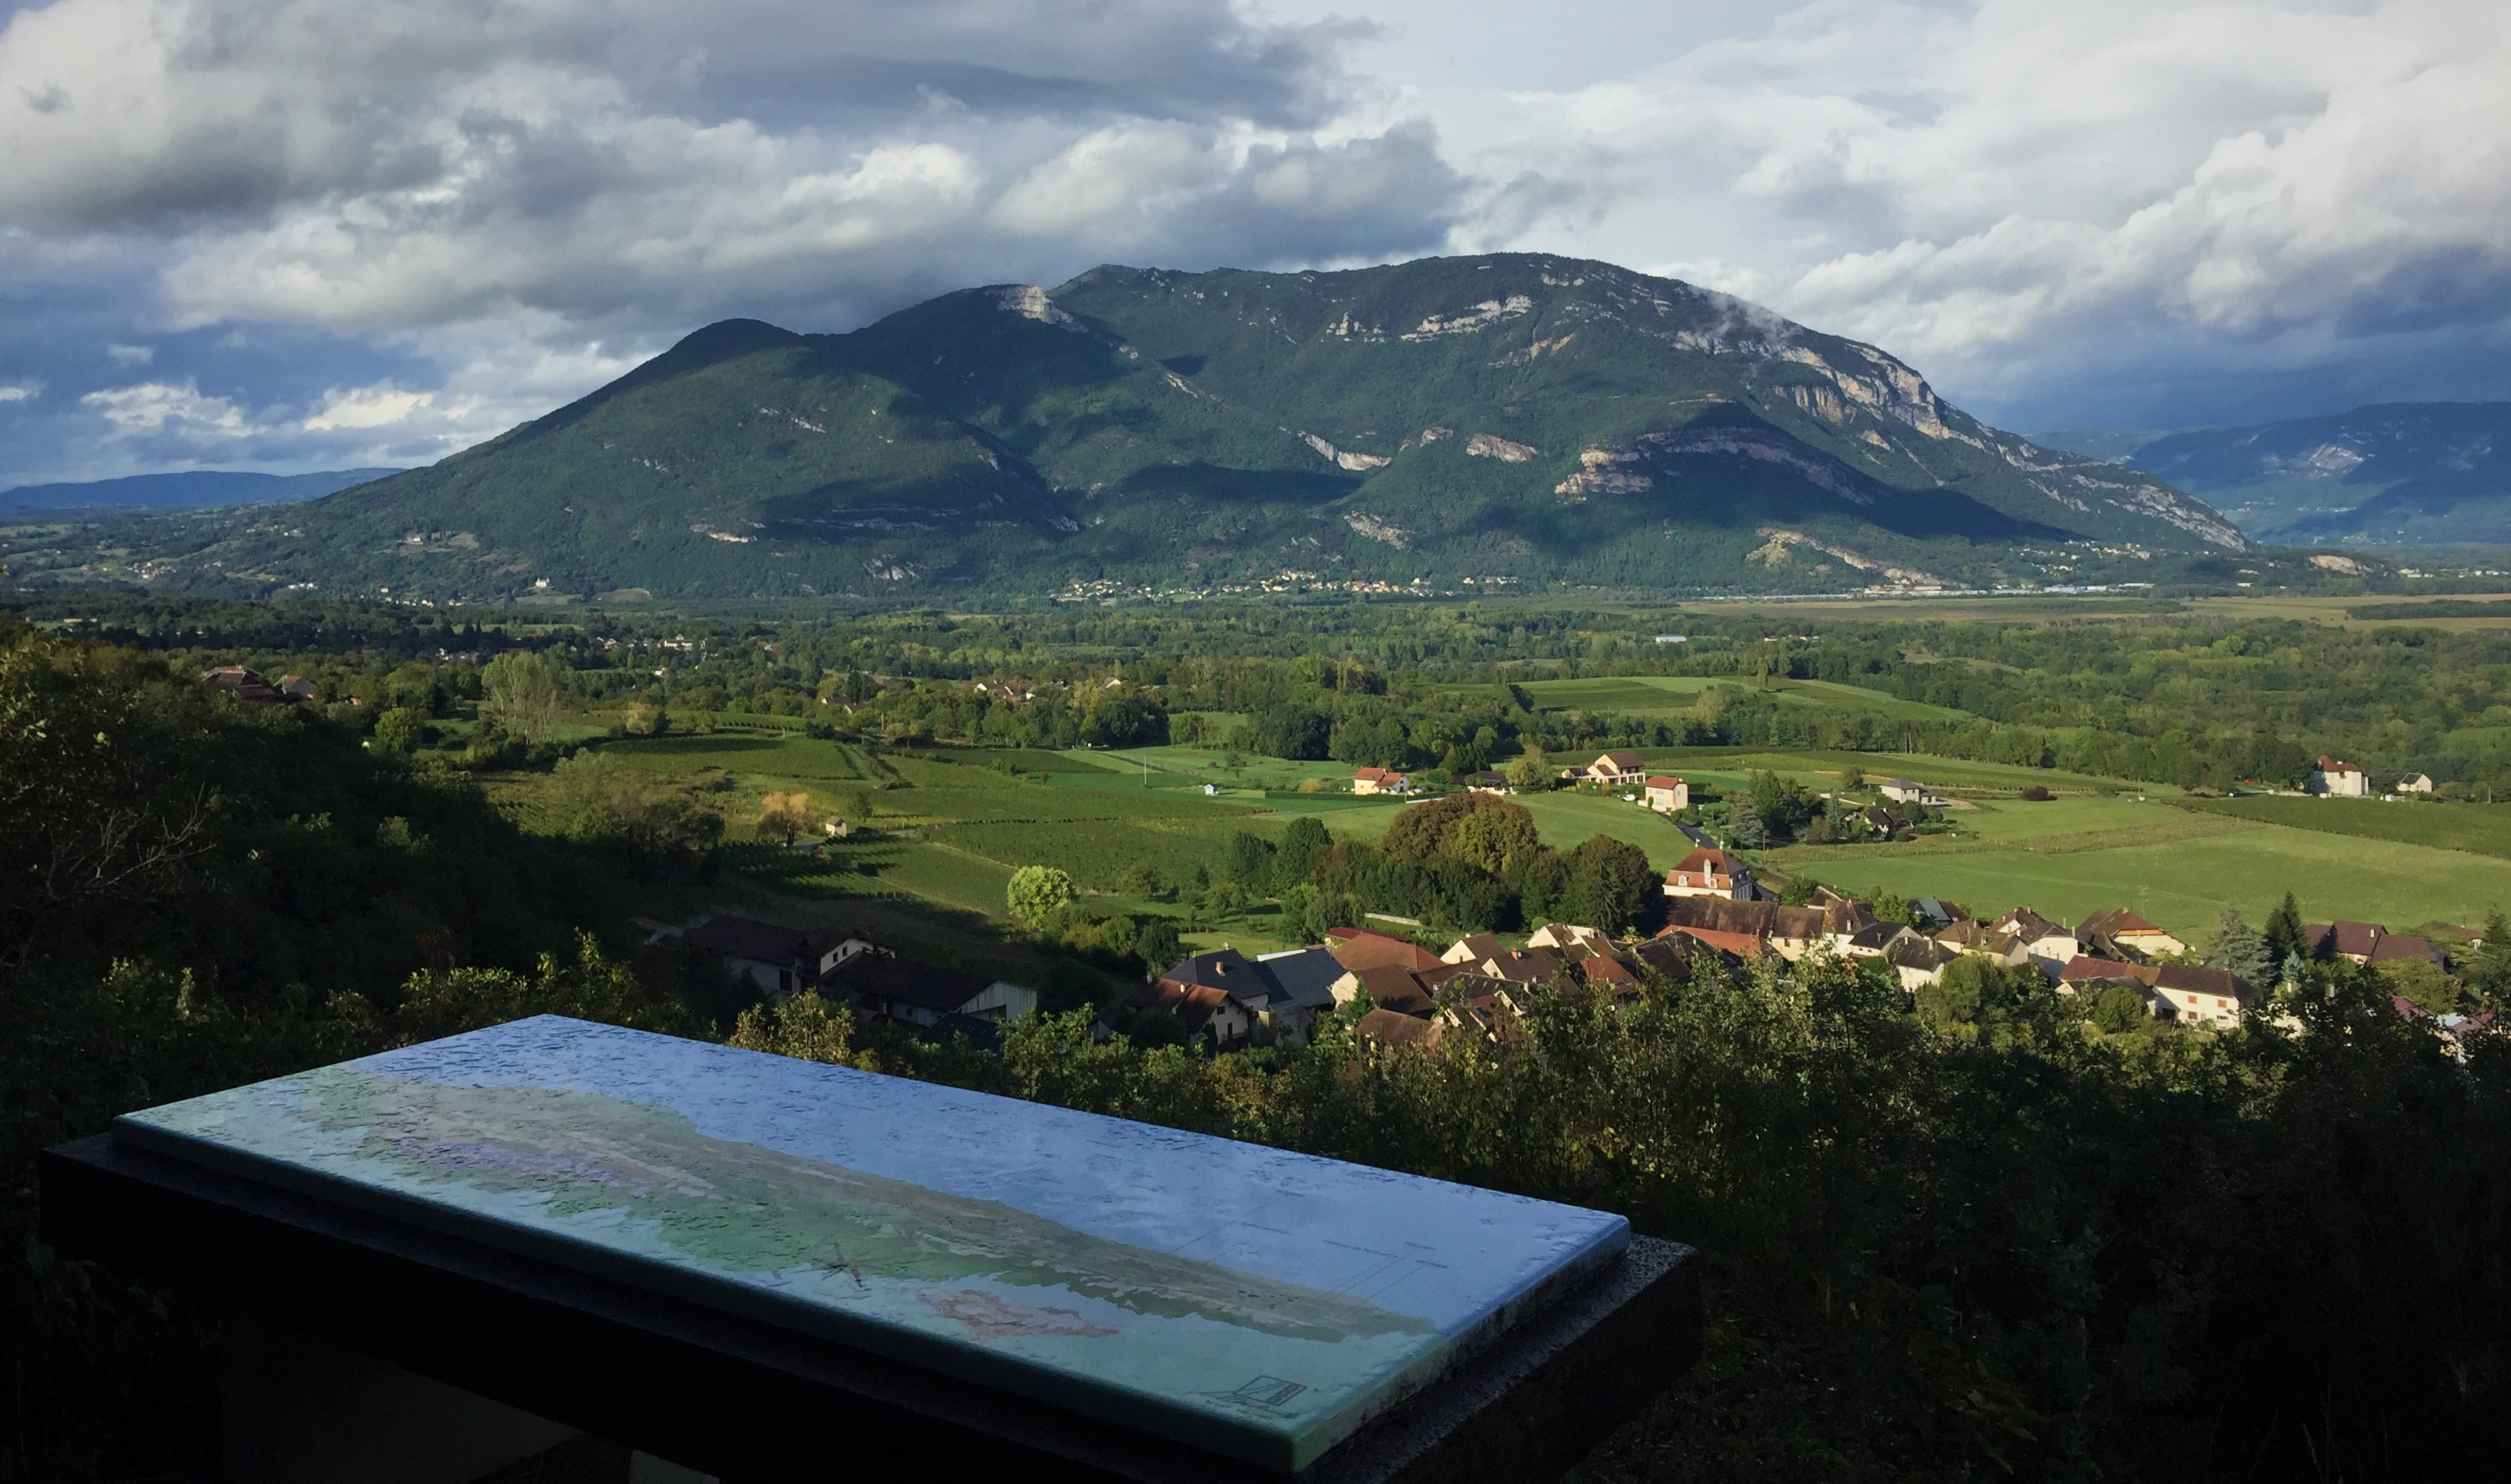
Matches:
[118,254,2242,598]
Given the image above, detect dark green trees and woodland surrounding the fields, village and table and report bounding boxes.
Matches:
[0,595,2511,1479]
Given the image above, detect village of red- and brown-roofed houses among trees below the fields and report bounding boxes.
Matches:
[656,753,2493,1052]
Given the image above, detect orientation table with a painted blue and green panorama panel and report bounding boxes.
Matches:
[42,1017,1700,1484]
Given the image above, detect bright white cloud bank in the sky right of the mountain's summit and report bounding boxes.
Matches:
[1286,0,2511,424]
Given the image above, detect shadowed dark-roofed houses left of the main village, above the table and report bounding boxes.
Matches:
[667,916,1037,1045]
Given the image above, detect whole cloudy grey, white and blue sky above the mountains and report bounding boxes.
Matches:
[0,0,2511,487]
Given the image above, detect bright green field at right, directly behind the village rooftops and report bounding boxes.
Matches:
[1763,799,2511,942]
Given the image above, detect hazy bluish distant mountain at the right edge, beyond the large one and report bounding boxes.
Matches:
[2127,402,2511,548]
